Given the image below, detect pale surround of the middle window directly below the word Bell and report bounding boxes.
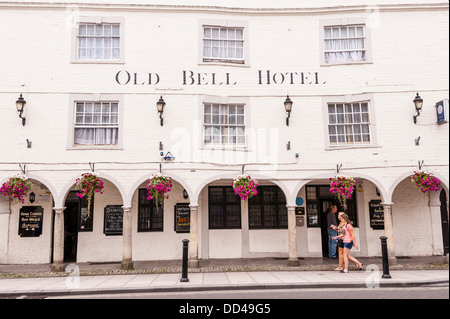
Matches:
[199,96,250,150]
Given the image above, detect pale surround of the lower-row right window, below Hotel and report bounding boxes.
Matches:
[322,94,379,150]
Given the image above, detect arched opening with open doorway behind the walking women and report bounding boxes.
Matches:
[296,176,384,257]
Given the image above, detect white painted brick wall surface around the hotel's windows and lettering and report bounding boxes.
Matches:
[0,0,449,262]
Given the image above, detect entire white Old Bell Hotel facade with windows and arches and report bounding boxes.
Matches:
[0,0,449,270]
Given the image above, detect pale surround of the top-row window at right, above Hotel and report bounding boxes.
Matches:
[319,18,373,66]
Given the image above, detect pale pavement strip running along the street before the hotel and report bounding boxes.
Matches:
[0,256,449,298]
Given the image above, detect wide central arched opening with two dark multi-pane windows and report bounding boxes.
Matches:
[199,174,289,259]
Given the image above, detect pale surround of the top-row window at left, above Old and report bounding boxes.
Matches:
[71,16,125,64]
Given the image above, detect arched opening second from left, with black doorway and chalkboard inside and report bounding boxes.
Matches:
[62,174,124,263]
